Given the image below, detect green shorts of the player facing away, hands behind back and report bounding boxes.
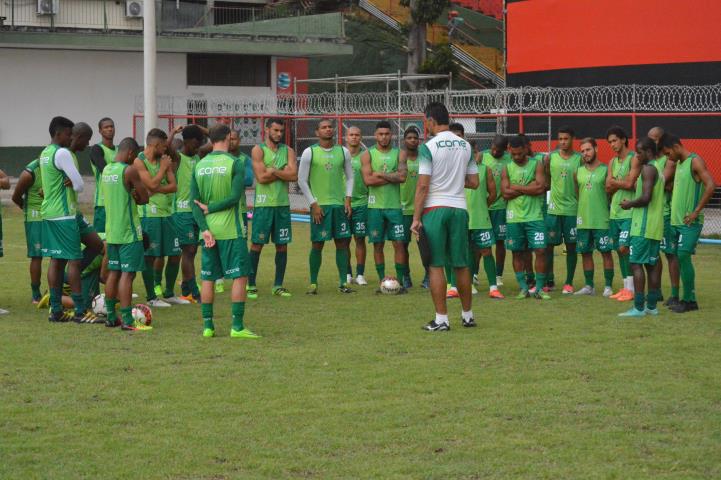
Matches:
[200,237,250,281]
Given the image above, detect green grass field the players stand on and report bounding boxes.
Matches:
[0,207,721,479]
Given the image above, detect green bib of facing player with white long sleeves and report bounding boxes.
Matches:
[308,144,345,205]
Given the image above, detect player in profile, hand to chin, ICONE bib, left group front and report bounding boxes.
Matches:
[100,138,153,331]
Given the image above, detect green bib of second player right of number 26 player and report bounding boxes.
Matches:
[576,163,609,230]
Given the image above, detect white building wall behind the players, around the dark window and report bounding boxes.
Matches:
[0,48,276,147]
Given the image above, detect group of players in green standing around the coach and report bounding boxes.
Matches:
[0,103,715,332]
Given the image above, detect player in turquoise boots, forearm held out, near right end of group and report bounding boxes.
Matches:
[618,137,665,317]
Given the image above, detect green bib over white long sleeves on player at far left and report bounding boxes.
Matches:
[40,144,78,220]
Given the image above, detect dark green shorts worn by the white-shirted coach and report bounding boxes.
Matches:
[421,207,468,268]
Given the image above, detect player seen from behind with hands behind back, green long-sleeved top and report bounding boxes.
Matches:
[191,123,260,339]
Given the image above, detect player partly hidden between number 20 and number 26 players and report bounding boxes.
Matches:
[481,135,511,287]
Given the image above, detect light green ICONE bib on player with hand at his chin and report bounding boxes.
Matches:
[100,162,143,244]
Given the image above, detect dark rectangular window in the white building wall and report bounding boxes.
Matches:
[187,53,270,87]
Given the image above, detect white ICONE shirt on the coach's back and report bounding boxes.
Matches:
[418,130,478,210]
